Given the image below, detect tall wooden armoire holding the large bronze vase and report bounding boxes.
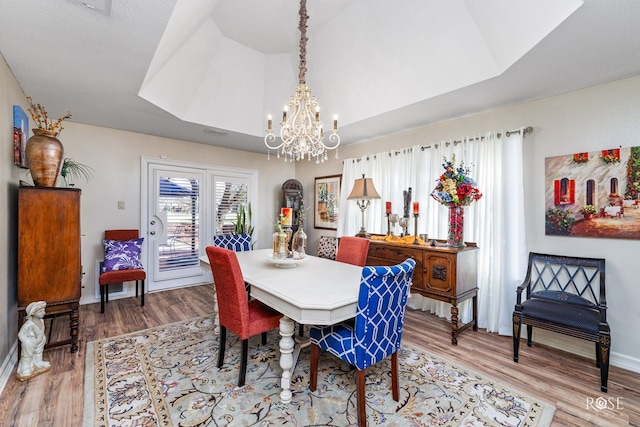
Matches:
[18,186,82,352]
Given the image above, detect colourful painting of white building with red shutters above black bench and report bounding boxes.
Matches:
[545,147,640,239]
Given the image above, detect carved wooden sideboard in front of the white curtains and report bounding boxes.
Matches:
[367,240,478,345]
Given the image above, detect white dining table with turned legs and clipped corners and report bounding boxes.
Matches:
[200,249,362,403]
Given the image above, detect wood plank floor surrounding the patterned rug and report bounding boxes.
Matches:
[0,285,640,427]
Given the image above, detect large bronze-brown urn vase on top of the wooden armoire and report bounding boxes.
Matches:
[25,129,64,187]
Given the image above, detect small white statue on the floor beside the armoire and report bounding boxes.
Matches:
[16,301,51,381]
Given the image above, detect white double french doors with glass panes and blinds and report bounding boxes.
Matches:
[140,157,259,291]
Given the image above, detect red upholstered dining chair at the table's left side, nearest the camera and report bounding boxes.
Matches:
[206,246,282,387]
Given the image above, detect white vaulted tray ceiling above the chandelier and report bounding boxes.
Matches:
[0,0,640,152]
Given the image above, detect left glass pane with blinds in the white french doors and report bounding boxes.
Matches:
[157,176,200,272]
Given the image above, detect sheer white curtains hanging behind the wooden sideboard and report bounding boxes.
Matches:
[337,129,527,335]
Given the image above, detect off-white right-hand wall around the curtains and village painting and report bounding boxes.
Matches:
[296,77,640,372]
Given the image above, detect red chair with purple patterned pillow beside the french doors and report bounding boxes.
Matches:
[98,230,147,313]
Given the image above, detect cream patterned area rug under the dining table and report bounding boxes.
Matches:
[83,317,555,426]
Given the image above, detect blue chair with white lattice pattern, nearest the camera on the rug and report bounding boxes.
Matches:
[309,259,416,426]
